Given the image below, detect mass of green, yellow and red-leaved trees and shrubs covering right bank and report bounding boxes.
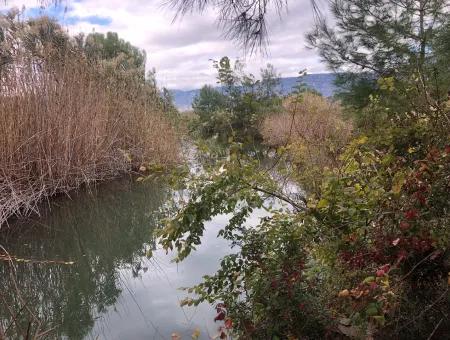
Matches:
[161,0,450,339]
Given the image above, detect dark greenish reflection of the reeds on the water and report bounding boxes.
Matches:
[0,179,168,339]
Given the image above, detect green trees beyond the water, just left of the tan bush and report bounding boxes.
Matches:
[190,57,280,143]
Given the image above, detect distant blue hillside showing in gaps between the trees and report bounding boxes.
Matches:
[170,73,336,111]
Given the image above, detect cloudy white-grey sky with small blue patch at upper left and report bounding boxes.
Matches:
[0,0,326,89]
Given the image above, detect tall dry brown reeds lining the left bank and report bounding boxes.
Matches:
[0,14,178,226]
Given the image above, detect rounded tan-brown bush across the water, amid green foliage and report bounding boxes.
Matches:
[261,92,352,191]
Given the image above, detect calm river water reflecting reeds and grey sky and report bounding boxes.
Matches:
[0,179,266,339]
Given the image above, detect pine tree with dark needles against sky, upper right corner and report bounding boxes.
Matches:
[308,0,449,107]
